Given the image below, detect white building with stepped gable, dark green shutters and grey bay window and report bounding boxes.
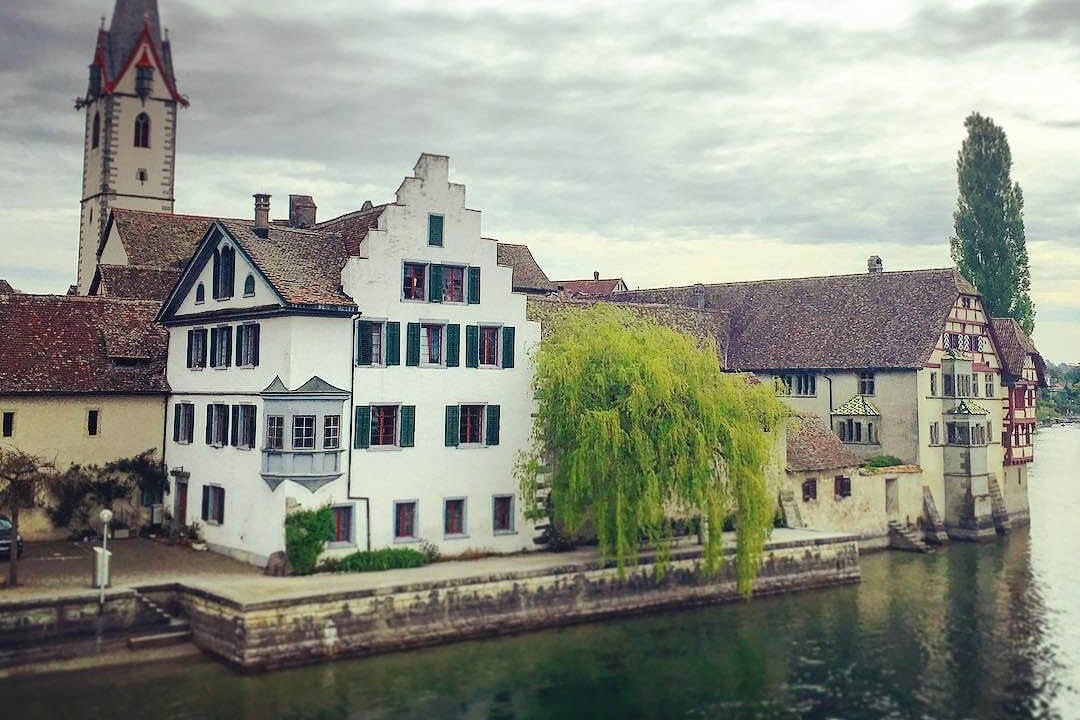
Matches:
[160,154,539,563]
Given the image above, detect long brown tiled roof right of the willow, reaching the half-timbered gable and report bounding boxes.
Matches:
[606,268,977,370]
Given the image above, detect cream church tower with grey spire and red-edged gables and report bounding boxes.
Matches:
[76,0,188,295]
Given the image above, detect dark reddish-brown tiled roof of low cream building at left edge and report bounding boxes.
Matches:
[0,295,168,394]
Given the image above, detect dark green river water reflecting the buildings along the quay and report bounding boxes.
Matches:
[0,426,1080,720]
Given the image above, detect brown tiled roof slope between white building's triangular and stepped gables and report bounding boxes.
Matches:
[220,220,355,308]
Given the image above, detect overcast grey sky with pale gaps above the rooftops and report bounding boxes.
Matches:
[0,0,1080,362]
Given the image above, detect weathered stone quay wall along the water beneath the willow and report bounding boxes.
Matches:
[180,533,860,671]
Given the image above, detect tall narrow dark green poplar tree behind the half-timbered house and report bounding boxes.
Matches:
[949,112,1035,335]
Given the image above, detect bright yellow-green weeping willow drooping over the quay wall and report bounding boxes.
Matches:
[517,304,786,593]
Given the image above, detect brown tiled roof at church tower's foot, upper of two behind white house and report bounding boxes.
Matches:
[98,209,215,268]
